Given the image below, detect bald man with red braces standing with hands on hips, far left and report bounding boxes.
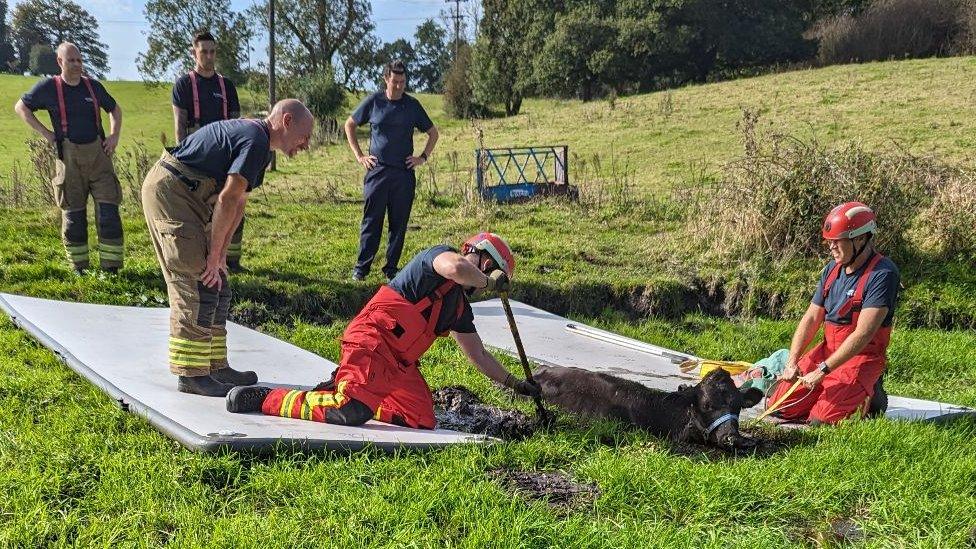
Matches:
[14,42,123,274]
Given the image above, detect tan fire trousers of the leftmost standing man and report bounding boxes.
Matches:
[51,139,124,269]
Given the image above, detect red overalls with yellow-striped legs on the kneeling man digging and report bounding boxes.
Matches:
[262,280,464,429]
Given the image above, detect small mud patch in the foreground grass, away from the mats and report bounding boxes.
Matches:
[488,468,600,509]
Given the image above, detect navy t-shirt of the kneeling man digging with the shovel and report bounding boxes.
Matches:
[389,244,476,334]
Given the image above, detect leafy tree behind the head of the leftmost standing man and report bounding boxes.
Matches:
[11,0,108,78]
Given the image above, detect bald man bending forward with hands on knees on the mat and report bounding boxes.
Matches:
[142,99,313,397]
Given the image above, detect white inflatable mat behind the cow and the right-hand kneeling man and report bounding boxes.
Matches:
[472,299,974,419]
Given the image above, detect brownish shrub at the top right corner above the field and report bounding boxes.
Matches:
[812,0,970,65]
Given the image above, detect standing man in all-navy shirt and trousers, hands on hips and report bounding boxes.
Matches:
[345,61,438,280]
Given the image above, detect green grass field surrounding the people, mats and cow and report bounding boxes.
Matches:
[0,58,976,548]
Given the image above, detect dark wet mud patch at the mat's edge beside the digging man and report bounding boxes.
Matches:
[433,385,538,440]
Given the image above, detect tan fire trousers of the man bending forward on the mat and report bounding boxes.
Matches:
[142,153,232,377]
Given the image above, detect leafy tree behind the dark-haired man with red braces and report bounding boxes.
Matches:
[136,0,254,82]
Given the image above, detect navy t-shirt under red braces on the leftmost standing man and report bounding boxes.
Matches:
[20,78,116,145]
